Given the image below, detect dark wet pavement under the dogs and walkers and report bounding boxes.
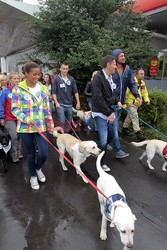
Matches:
[0,133,167,250]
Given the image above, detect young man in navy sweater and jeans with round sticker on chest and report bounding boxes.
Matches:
[52,62,80,132]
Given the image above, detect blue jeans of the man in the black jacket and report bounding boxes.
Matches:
[95,116,122,164]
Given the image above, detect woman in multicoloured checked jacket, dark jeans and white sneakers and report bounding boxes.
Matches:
[12,62,54,190]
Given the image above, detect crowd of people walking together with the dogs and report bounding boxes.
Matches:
[0,49,150,190]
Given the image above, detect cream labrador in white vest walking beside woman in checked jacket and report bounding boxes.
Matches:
[53,131,101,183]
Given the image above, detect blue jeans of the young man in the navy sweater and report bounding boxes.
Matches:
[56,105,72,132]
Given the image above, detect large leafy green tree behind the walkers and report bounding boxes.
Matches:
[27,0,152,87]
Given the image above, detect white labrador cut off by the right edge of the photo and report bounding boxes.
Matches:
[132,140,167,171]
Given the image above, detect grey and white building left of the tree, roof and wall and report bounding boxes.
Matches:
[0,0,39,73]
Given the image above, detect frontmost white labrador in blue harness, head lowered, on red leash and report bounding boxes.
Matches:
[96,152,136,250]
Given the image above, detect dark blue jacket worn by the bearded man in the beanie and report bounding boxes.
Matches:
[112,65,140,104]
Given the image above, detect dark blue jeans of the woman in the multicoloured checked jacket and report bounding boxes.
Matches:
[19,132,48,176]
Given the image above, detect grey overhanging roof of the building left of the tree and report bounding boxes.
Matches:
[0,0,39,57]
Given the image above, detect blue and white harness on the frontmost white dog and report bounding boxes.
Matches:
[104,194,126,222]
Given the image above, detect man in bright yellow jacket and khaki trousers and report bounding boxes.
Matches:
[122,68,150,141]
